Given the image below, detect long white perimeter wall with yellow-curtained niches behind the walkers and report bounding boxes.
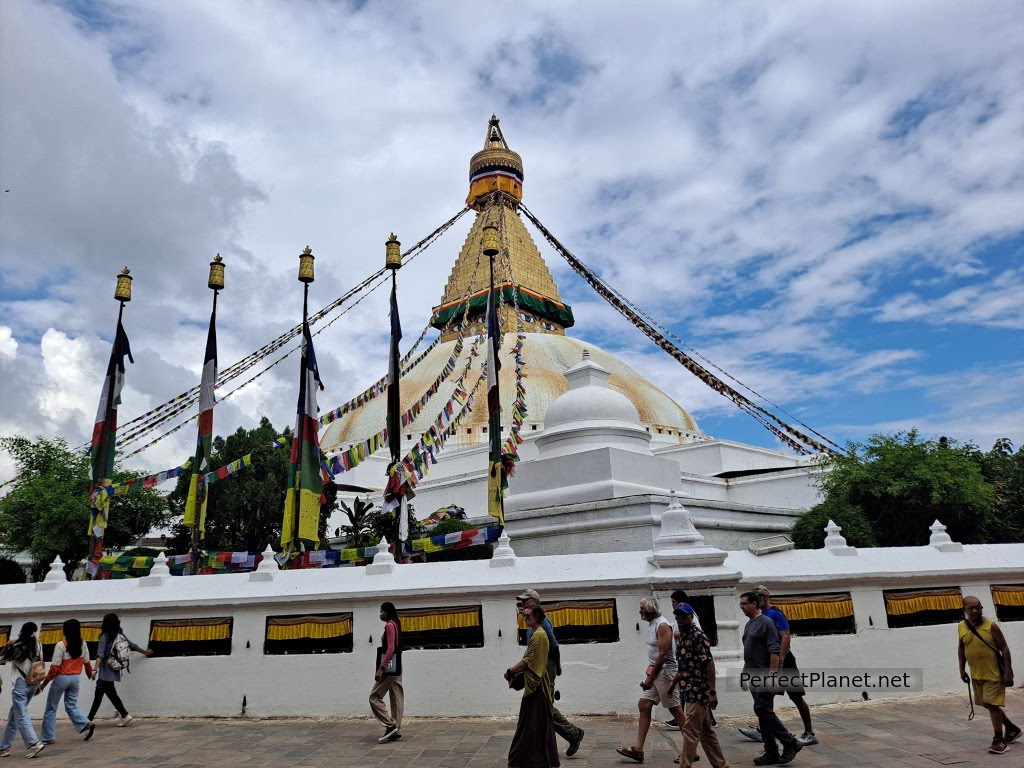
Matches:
[0,545,1024,717]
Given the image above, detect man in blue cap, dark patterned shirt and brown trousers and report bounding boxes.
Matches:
[672,603,729,768]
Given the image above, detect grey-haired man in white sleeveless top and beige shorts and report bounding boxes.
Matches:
[615,597,683,763]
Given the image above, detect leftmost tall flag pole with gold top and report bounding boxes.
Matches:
[86,267,135,578]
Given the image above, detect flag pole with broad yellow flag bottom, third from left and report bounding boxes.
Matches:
[281,246,324,555]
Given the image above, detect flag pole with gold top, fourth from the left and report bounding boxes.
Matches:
[384,232,409,562]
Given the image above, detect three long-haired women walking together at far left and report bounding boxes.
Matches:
[0,613,152,758]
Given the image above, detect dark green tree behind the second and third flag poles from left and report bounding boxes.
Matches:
[167,417,290,554]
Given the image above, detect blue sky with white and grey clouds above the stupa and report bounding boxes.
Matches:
[0,0,1024,480]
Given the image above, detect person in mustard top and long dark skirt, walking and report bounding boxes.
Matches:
[505,605,560,768]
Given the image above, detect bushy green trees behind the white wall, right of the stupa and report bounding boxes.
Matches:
[794,430,1024,548]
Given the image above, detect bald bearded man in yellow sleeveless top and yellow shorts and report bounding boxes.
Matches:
[956,595,1021,755]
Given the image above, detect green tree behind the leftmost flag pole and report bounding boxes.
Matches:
[0,436,169,579]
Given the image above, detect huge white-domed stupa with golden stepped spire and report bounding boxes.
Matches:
[321,117,818,554]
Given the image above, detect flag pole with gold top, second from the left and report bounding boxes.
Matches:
[182,253,224,575]
